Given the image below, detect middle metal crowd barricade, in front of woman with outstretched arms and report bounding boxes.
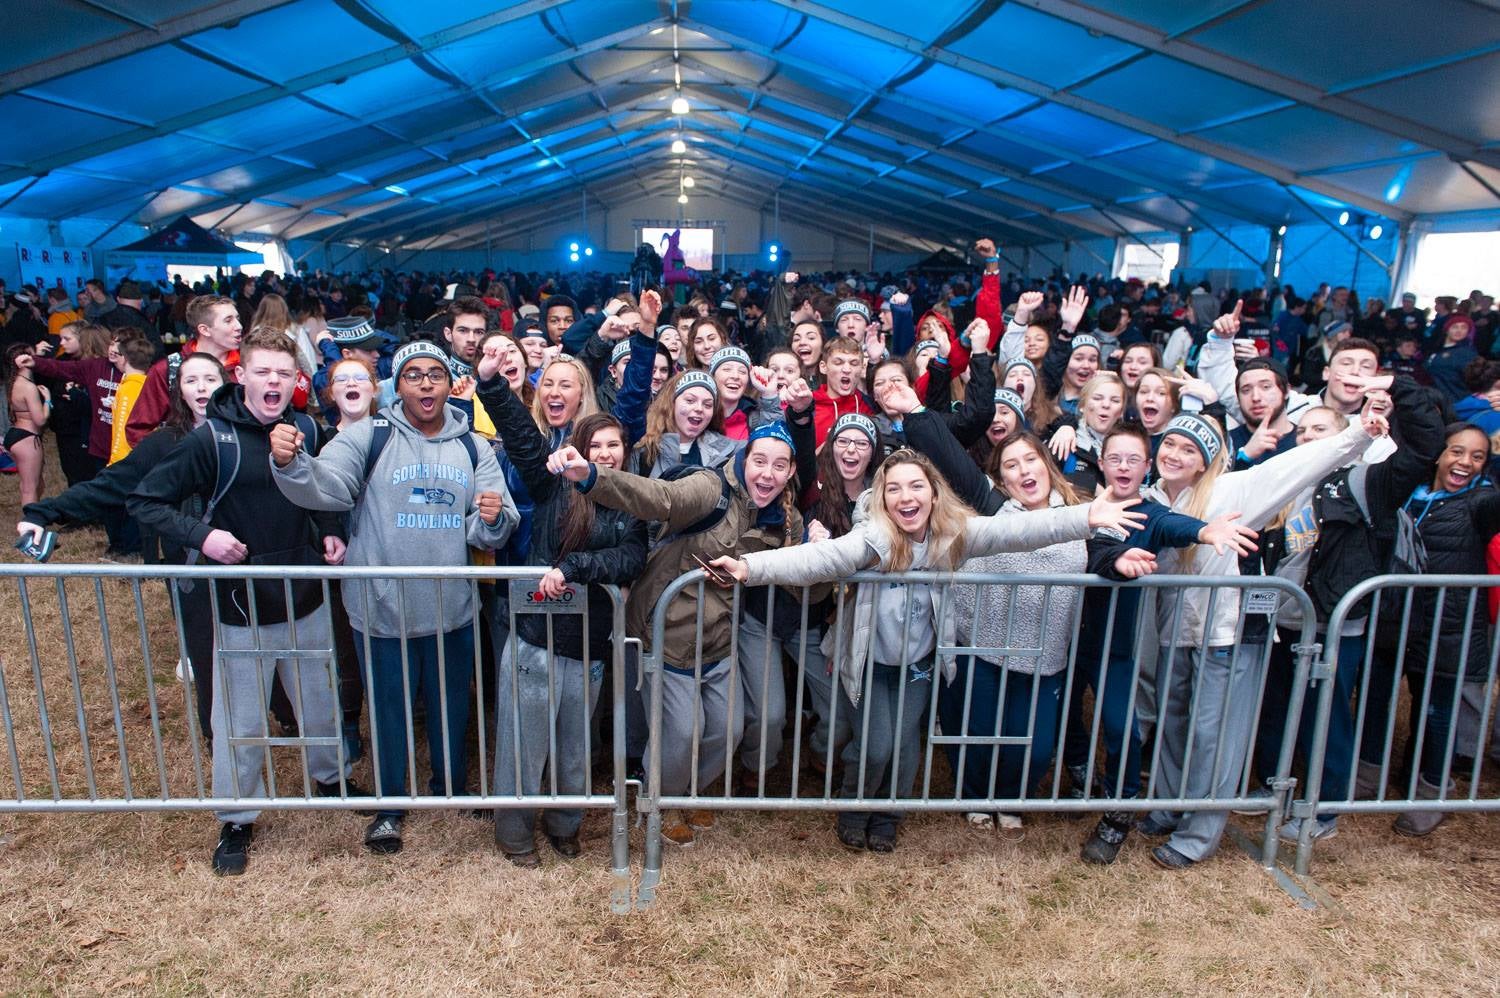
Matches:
[638,570,1317,908]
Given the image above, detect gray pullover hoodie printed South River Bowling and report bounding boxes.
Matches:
[272,404,521,638]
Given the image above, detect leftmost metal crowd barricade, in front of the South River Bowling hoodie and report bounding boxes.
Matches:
[0,564,633,911]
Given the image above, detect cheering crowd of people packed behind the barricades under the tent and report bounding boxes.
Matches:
[0,240,1500,873]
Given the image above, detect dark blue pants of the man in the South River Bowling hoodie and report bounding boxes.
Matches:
[354,626,474,816]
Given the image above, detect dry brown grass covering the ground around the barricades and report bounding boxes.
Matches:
[0,444,1500,995]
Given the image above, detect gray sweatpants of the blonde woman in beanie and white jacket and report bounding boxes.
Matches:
[1152,644,1265,860]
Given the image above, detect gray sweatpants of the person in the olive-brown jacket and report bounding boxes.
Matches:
[647,659,744,797]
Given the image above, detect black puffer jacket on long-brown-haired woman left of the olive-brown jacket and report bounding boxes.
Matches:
[479,369,647,660]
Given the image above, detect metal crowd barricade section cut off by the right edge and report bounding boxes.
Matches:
[1292,576,1500,873]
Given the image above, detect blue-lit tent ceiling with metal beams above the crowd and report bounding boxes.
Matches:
[0,0,1500,248]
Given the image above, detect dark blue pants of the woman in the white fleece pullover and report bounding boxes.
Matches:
[938,656,1067,800]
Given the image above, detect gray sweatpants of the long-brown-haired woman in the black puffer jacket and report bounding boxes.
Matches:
[495,639,605,854]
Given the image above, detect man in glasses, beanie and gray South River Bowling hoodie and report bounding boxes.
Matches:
[272,341,521,854]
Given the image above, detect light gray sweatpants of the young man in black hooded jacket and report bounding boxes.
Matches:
[213,606,341,824]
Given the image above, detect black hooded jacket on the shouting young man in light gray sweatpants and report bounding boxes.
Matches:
[126,384,345,627]
